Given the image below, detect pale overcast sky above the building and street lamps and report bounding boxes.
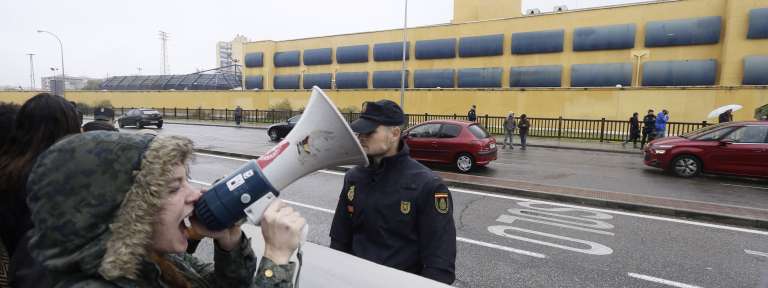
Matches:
[0,0,647,88]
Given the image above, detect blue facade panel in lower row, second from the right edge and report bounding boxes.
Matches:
[643,60,717,86]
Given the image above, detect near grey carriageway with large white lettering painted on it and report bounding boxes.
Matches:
[188,151,768,288]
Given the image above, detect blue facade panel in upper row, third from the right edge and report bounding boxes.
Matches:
[573,24,637,51]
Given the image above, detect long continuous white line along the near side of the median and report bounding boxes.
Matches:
[189,153,768,236]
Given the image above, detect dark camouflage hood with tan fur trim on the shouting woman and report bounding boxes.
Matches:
[27,131,193,283]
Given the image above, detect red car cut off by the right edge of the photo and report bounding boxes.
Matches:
[644,121,768,177]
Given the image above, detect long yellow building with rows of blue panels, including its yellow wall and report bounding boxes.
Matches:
[0,0,768,122]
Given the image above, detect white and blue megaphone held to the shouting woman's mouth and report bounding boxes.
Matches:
[195,86,368,231]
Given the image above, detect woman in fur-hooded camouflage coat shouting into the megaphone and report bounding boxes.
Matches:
[27,131,305,288]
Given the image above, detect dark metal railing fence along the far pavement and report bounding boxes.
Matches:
[99,107,711,142]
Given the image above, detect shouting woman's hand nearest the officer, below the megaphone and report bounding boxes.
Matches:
[261,199,306,265]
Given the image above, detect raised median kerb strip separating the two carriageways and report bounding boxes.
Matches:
[190,149,768,230]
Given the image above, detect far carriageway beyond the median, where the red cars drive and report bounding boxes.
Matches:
[121,124,768,208]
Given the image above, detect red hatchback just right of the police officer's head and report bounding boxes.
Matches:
[403,120,496,173]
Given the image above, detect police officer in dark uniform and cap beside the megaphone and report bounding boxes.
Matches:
[330,100,456,284]
